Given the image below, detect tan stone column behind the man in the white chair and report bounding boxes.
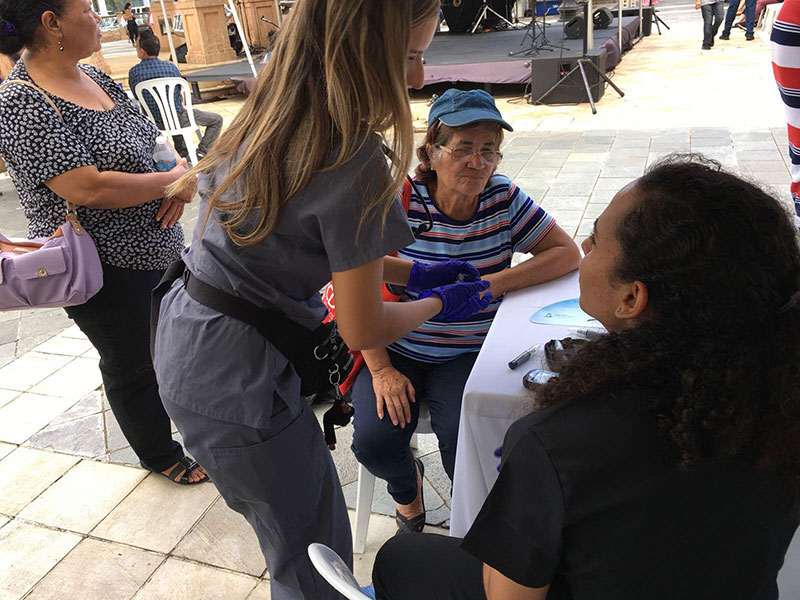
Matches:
[174,0,236,64]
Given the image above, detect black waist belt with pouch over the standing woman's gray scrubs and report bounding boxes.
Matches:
[153,260,353,396]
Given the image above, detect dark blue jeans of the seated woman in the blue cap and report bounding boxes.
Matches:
[352,350,478,504]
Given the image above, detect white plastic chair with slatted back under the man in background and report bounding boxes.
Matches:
[133,77,200,165]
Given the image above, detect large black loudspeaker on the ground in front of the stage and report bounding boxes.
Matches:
[530,49,606,104]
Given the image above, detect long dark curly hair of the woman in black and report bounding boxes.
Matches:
[534,155,800,494]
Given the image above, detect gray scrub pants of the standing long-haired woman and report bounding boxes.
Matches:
[163,396,353,600]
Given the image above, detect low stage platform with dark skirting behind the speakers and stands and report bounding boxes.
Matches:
[186,17,639,93]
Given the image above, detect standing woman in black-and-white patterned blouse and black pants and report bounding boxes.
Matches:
[0,0,208,484]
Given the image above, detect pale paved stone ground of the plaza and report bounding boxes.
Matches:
[0,10,800,600]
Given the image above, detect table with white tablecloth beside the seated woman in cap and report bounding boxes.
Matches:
[450,271,579,537]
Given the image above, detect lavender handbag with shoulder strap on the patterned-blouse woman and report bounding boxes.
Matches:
[0,79,103,311]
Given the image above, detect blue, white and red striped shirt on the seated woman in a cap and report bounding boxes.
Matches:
[389,175,555,362]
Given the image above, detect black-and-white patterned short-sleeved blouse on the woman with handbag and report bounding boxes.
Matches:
[0,60,183,270]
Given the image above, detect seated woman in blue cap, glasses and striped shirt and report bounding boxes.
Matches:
[353,89,580,532]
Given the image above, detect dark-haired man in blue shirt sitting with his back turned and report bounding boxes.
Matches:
[128,30,222,159]
